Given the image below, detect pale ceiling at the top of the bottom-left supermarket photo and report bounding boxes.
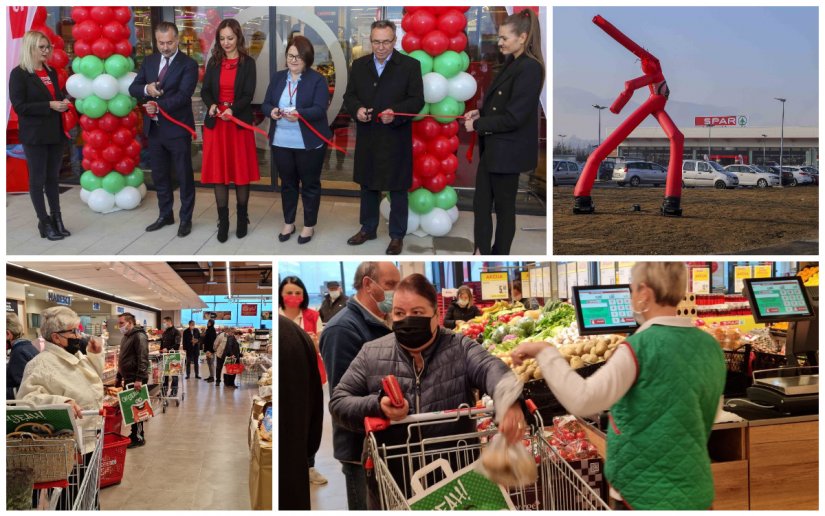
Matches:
[10,261,207,310]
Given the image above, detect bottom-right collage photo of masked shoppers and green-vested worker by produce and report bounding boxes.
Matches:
[277,261,819,510]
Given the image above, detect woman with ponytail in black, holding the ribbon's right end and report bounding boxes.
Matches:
[464,9,544,255]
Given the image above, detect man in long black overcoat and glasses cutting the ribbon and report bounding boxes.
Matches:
[344,20,424,254]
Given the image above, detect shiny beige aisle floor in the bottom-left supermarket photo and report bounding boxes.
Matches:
[100,376,258,510]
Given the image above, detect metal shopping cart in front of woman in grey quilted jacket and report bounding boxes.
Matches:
[365,401,609,510]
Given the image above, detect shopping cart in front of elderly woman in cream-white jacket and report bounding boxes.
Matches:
[6,410,105,511]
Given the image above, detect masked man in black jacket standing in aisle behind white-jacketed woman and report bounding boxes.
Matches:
[117,312,149,448]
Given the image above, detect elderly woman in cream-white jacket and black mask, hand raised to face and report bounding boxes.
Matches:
[17,306,103,453]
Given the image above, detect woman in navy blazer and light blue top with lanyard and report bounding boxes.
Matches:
[261,36,332,244]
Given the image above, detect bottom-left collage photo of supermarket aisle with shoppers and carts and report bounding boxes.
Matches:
[6,261,273,510]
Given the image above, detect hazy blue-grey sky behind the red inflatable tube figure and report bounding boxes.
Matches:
[553,7,819,143]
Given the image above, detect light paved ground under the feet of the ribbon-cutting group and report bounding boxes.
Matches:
[6,187,547,256]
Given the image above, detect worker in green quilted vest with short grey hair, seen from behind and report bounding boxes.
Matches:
[512,262,725,510]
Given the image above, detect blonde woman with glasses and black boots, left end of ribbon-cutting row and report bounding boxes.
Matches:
[9,31,71,240]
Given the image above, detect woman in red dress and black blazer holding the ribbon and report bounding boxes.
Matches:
[201,18,261,242]
